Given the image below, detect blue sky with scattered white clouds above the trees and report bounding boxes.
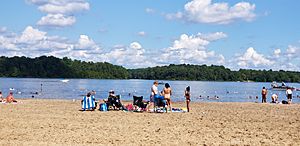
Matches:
[0,0,300,71]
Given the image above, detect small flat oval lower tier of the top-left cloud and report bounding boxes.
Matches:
[37,14,76,27]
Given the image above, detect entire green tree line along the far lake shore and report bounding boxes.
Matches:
[0,56,300,82]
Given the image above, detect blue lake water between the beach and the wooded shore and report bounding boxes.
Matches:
[0,78,300,103]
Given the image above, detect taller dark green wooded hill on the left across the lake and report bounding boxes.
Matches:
[0,56,129,79]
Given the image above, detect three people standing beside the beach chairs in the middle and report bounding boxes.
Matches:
[150,81,191,112]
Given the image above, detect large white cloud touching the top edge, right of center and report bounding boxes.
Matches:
[166,0,256,24]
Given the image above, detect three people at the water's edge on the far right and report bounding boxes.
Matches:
[261,87,293,104]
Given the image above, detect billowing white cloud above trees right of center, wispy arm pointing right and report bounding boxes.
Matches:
[159,32,226,64]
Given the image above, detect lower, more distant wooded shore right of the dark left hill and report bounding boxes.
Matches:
[129,64,300,82]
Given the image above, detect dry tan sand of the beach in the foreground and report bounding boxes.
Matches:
[0,99,300,145]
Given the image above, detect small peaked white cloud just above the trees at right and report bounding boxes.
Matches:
[237,47,275,68]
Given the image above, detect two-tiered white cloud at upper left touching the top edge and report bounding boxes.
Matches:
[27,0,90,27]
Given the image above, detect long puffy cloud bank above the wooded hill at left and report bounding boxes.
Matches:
[0,26,102,61]
